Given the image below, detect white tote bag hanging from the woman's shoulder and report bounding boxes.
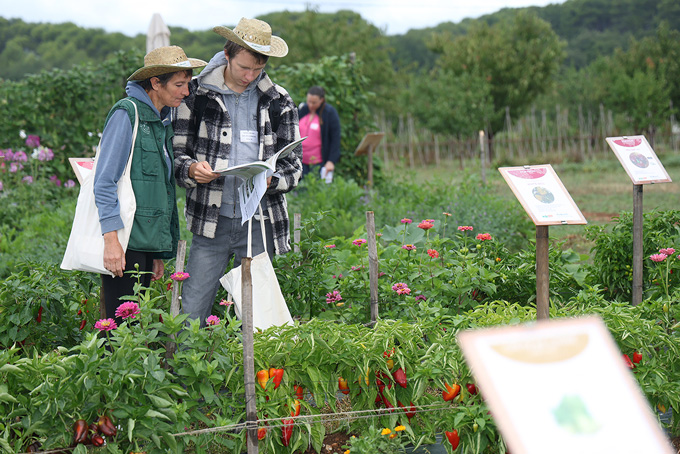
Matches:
[61,101,139,276]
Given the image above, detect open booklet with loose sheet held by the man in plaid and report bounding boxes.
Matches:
[213,137,307,224]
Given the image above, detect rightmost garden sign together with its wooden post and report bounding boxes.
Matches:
[605,136,671,306]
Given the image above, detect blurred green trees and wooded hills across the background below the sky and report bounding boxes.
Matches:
[0,0,680,160]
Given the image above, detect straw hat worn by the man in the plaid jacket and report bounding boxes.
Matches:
[213,17,288,57]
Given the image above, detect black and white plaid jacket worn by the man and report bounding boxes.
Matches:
[173,73,302,254]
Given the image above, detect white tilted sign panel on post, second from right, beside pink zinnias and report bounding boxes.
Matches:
[498,164,588,225]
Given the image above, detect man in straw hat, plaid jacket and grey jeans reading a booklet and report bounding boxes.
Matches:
[173,18,302,326]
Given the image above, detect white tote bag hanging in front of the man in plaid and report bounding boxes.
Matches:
[220,206,293,330]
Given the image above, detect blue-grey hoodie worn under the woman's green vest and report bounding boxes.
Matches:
[94,82,172,234]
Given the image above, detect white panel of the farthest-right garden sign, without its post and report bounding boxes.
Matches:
[606,136,671,184]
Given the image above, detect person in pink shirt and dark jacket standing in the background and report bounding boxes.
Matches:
[299,86,340,181]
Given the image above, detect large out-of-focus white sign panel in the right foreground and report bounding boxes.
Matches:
[458,317,675,454]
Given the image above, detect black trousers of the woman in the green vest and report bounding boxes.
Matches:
[101,249,153,325]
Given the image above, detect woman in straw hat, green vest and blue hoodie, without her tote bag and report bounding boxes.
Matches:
[94,46,207,322]
